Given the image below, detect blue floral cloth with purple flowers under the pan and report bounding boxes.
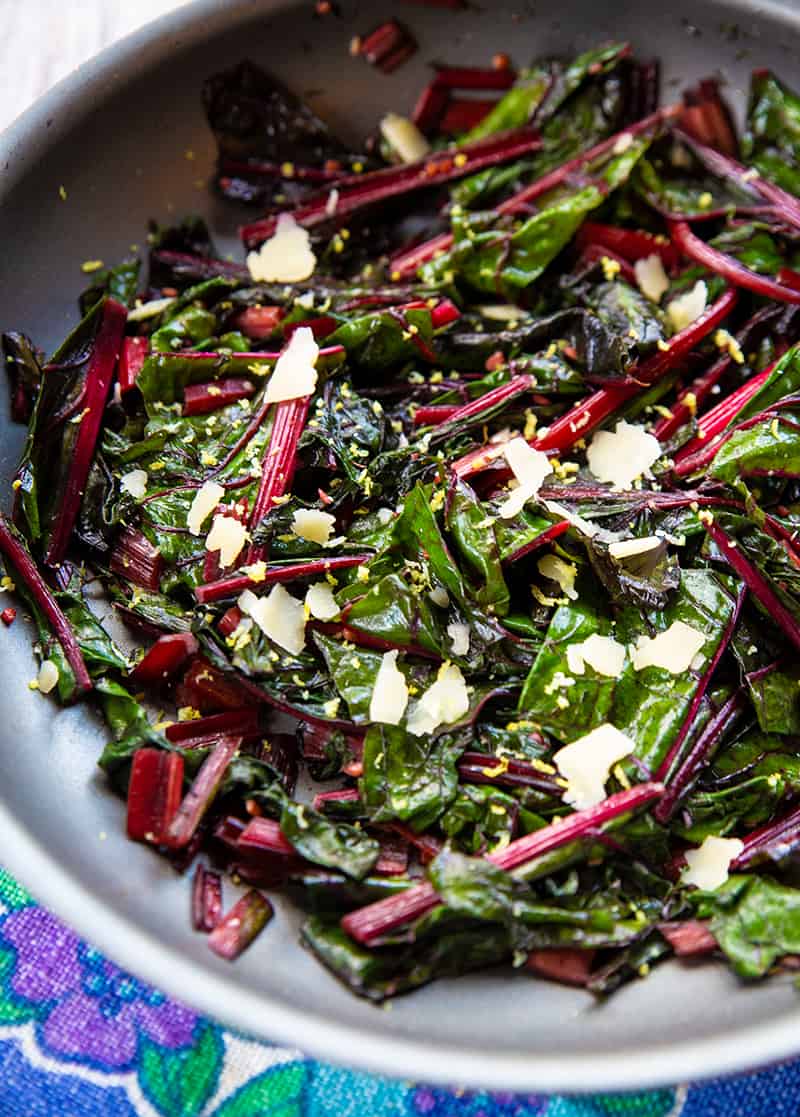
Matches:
[0,869,800,1117]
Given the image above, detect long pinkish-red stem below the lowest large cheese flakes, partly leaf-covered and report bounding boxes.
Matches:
[342,783,664,946]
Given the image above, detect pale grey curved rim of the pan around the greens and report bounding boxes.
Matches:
[0,0,800,1094]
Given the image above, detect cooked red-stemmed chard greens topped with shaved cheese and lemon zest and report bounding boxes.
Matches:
[0,34,800,1001]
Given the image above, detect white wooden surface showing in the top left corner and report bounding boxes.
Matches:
[0,0,188,132]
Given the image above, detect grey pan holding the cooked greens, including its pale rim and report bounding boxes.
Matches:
[0,0,800,1091]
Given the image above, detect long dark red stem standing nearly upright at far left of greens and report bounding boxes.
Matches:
[45,298,127,566]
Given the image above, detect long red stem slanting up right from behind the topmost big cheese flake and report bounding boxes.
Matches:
[241,127,541,248]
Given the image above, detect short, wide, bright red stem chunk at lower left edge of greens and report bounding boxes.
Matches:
[127,748,183,846]
